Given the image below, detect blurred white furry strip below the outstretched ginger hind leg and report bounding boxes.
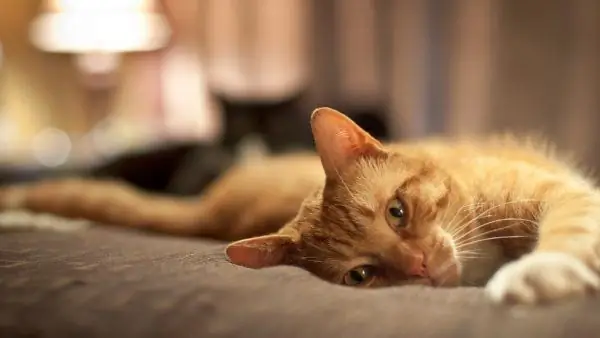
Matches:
[0,210,91,232]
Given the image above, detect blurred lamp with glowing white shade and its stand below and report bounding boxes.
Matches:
[29,0,171,164]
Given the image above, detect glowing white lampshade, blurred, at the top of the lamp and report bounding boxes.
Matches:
[30,0,171,53]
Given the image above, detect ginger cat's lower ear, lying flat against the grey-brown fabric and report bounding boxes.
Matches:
[225,234,294,269]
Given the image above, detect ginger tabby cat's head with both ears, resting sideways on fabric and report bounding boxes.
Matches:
[226,108,462,287]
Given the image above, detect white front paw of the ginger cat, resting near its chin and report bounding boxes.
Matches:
[486,252,600,304]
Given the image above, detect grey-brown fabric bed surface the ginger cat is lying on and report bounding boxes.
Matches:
[0,227,600,338]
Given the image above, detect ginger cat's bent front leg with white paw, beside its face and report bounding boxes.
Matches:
[486,189,600,304]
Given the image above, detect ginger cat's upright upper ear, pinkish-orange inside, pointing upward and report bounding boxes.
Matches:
[310,107,384,177]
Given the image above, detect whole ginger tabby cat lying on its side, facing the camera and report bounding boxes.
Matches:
[0,108,600,304]
